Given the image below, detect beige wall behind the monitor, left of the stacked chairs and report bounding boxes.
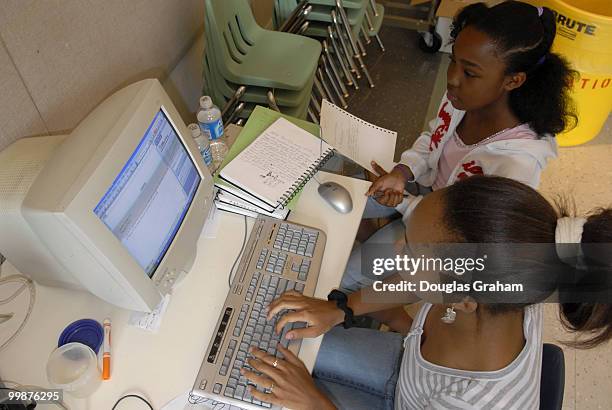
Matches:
[0,0,273,150]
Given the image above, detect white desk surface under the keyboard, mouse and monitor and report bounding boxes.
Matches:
[0,172,369,410]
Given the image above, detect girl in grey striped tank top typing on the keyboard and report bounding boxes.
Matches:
[242,176,612,410]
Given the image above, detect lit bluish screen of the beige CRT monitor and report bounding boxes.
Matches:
[94,108,201,277]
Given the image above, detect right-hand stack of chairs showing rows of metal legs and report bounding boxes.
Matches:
[274,0,385,122]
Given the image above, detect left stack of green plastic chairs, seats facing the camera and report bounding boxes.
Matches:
[202,0,322,124]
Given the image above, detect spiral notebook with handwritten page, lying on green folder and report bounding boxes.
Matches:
[219,118,334,208]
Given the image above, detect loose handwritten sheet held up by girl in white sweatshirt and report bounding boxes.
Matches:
[321,100,397,171]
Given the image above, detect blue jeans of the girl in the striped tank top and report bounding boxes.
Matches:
[313,326,403,410]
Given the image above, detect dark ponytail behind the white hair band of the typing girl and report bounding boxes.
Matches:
[559,209,612,349]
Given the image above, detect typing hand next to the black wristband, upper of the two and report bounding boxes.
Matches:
[267,291,344,340]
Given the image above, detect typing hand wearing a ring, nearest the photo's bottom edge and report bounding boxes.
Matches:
[241,344,336,410]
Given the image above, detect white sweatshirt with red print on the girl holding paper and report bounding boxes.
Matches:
[396,94,557,220]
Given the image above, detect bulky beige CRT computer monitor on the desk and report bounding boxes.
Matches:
[0,80,213,311]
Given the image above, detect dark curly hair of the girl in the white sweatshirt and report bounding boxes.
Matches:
[451,1,578,135]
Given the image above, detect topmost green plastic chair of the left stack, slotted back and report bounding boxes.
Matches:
[205,0,321,90]
